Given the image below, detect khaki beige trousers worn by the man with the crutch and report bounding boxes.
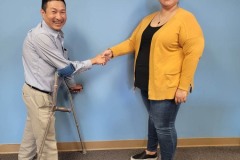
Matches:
[18,84,58,160]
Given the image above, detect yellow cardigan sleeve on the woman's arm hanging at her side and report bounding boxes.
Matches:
[178,14,204,91]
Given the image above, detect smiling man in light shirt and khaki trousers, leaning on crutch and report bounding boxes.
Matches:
[18,0,106,160]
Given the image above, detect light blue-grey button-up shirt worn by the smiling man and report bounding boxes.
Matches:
[22,21,92,92]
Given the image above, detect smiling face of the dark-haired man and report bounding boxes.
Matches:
[41,1,67,31]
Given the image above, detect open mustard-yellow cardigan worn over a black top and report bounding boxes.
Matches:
[110,8,204,100]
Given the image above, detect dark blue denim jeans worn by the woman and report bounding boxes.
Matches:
[141,91,180,160]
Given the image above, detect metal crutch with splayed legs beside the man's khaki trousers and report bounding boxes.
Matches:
[37,72,87,160]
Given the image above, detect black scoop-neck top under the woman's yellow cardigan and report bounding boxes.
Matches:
[135,23,161,91]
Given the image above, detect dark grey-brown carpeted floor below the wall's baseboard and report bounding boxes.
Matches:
[0,147,240,160]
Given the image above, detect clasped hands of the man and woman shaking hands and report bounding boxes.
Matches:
[91,49,113,65]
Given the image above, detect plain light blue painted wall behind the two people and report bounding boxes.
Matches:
[0,0,240,144]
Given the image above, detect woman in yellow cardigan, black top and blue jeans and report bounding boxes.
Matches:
[103,0,204,160]
